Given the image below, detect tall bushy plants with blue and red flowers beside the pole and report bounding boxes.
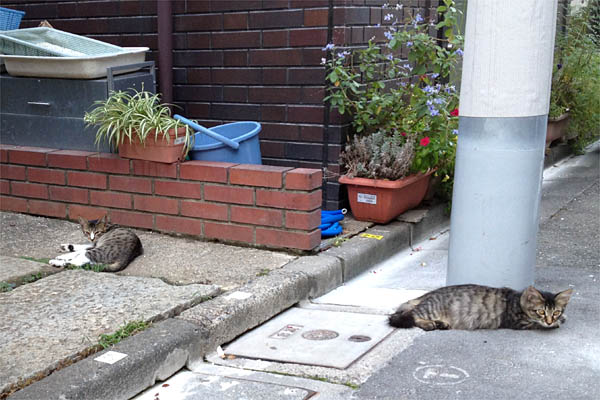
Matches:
[323,0,462,193]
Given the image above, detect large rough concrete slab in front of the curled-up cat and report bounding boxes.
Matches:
[0,270,219,393]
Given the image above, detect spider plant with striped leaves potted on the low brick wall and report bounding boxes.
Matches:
[83,89,193,153]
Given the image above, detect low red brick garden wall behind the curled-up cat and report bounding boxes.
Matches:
[0,145,322,250]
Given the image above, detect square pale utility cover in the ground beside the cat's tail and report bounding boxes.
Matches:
[225,308,393,369]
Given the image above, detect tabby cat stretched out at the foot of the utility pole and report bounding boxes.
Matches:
[389,285,573,331]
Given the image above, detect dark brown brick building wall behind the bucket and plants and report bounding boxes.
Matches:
[3,0,438,209]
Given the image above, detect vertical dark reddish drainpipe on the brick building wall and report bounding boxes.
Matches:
[156,0,173,103]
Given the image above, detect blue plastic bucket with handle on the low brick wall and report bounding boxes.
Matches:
[189,121,262,164]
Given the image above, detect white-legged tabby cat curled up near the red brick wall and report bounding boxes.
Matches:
[50,215,143,272]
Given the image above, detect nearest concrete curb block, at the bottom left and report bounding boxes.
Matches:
[11,319,204,400]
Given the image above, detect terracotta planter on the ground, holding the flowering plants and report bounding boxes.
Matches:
[339,171,434,224]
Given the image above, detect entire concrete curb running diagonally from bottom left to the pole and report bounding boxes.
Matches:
[10,205,448,400]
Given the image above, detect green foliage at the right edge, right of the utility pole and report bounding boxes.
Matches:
[548,1,600,150]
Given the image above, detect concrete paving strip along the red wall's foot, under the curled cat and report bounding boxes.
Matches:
[0,212,296,290]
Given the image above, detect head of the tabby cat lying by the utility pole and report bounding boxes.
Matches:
[521,286,573,328]
